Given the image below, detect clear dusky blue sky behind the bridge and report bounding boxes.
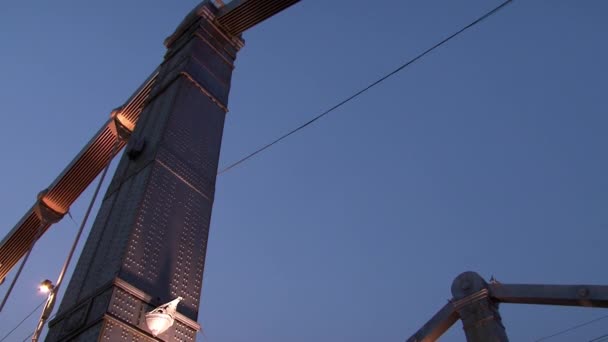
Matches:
[0,0,608,342]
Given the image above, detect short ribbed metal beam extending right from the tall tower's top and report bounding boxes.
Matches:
[217,0,300,36]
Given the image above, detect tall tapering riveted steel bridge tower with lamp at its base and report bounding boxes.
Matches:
[47,1,243,341]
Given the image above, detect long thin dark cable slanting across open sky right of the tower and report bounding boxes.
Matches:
[218,0,513,175]
